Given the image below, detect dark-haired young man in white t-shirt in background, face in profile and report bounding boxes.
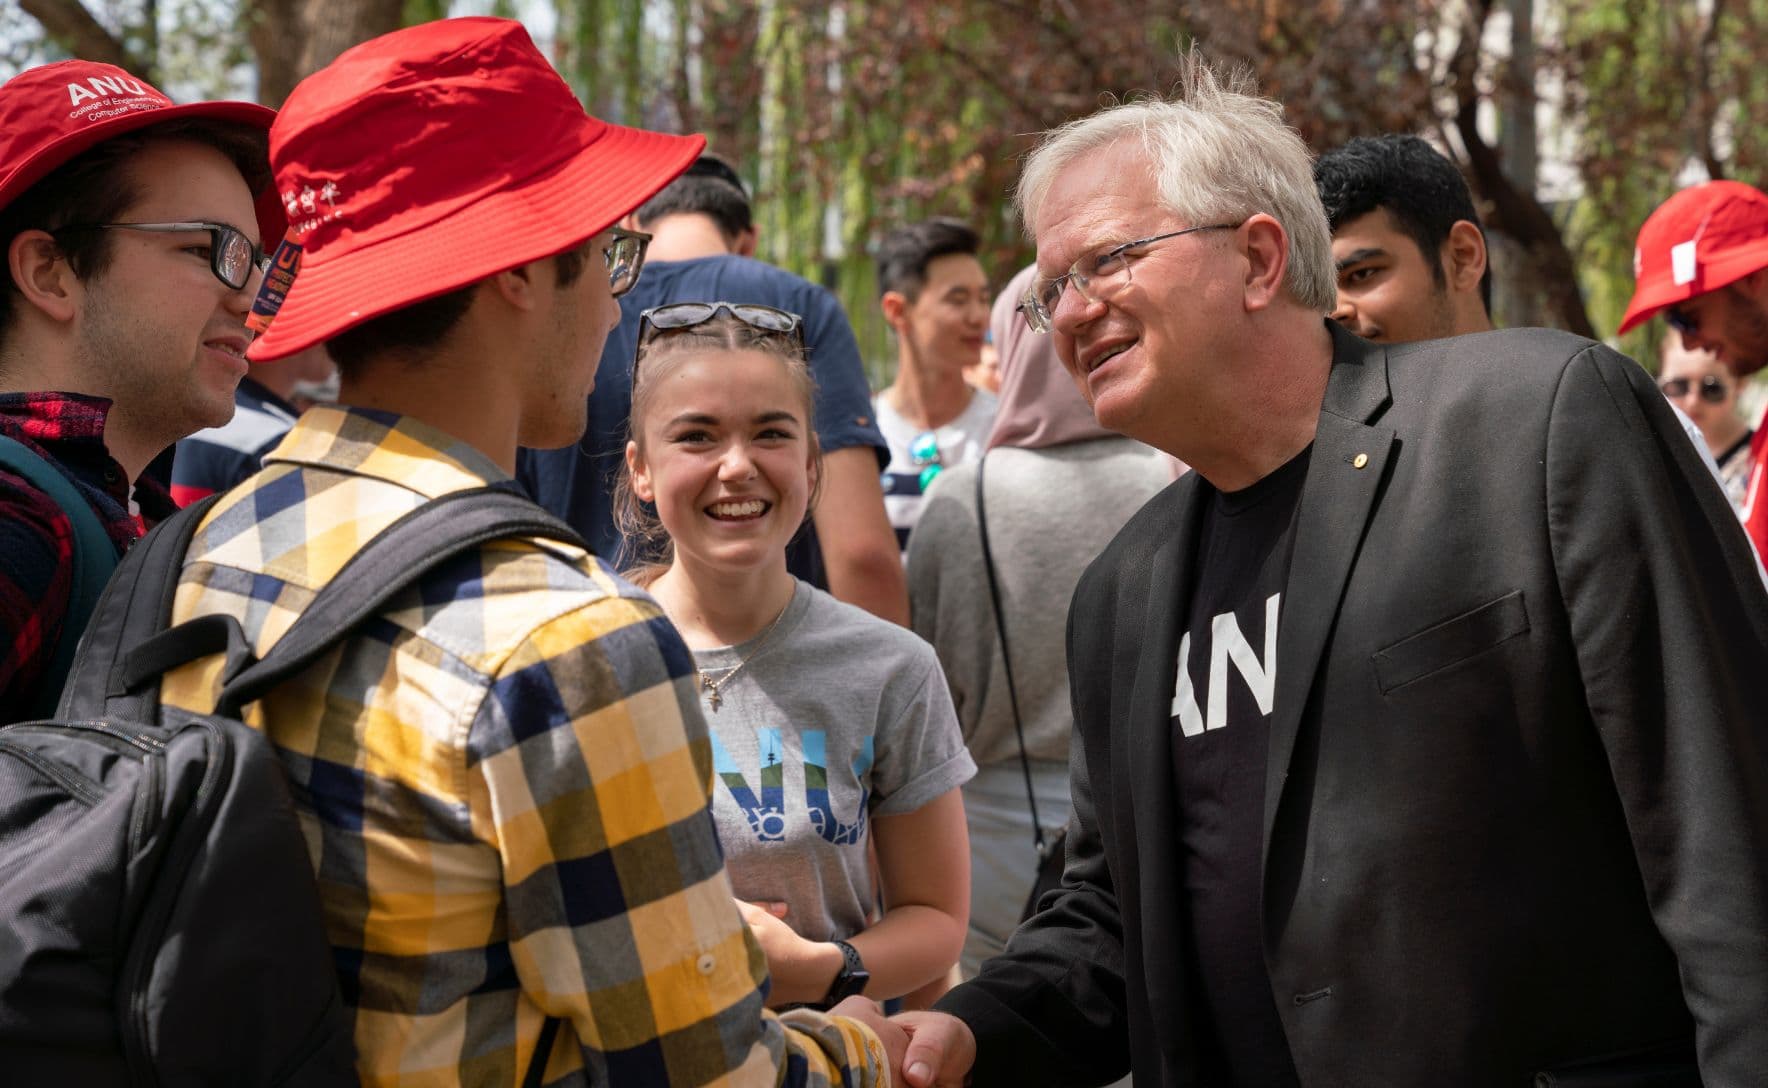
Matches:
[873,219,999,552]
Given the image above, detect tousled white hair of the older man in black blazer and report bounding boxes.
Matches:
[1013,48,1338,313]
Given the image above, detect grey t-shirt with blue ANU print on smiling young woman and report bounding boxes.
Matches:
[693,582,976,941]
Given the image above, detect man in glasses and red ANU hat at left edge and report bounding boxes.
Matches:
[0,60,281,724]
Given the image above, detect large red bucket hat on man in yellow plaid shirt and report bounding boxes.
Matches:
[248,18,705,361]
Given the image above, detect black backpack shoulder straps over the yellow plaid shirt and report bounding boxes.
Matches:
[60,487,587,722]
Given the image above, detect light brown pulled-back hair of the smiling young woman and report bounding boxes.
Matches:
[613,311,822,586]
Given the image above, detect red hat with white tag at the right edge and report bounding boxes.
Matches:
[1619,180,1768,333]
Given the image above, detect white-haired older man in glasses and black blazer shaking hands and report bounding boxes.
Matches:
[900,57,1768,1088]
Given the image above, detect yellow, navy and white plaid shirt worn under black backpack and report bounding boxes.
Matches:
[161,407,889,1088]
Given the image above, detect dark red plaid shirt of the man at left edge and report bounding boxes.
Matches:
[0,393,175,724]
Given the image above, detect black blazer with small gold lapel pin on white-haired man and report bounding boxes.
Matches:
[939,327,1768,1088]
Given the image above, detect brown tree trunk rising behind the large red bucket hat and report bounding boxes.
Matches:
[244,0,405,106]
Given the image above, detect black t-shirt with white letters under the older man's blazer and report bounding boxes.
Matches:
[1172,440,1308,1088]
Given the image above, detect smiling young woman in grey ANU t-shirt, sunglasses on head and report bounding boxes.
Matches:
[615,303,976,1007]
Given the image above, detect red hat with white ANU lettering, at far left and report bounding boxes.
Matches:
[0,60,283,237]
